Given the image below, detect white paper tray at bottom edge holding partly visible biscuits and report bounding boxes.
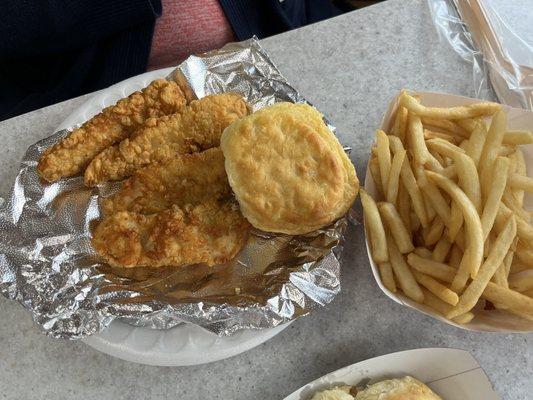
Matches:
[285,348,499,400]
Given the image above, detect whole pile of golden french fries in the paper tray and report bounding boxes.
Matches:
[361,91,533,324]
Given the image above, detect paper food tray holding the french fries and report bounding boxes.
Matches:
[365,92,533,332]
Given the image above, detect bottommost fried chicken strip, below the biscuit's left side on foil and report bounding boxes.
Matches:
[92,201,249,268]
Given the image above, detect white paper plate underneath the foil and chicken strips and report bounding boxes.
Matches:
[56,68,289,366]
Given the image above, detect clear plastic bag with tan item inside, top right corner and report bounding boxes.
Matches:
[428,0,533,110]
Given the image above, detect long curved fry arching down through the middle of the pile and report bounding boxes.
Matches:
[426,171,484,278]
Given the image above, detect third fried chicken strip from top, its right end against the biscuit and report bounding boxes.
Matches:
[102,147,231,215]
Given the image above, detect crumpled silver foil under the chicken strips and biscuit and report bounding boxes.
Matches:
[0,39,347,339]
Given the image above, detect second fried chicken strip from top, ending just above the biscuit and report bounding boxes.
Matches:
[85,93,248,186]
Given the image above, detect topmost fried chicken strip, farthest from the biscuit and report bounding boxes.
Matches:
[37,79,186,182]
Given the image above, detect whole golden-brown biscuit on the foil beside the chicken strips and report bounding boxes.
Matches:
[221,103,359,234]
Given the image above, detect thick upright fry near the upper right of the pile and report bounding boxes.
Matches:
[479,110,507,199]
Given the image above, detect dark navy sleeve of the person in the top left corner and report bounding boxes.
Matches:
[0,0,161,58]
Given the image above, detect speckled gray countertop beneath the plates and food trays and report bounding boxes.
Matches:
[0,0,533,400]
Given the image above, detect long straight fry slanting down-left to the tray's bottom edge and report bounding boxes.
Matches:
[446,218,516,318]
